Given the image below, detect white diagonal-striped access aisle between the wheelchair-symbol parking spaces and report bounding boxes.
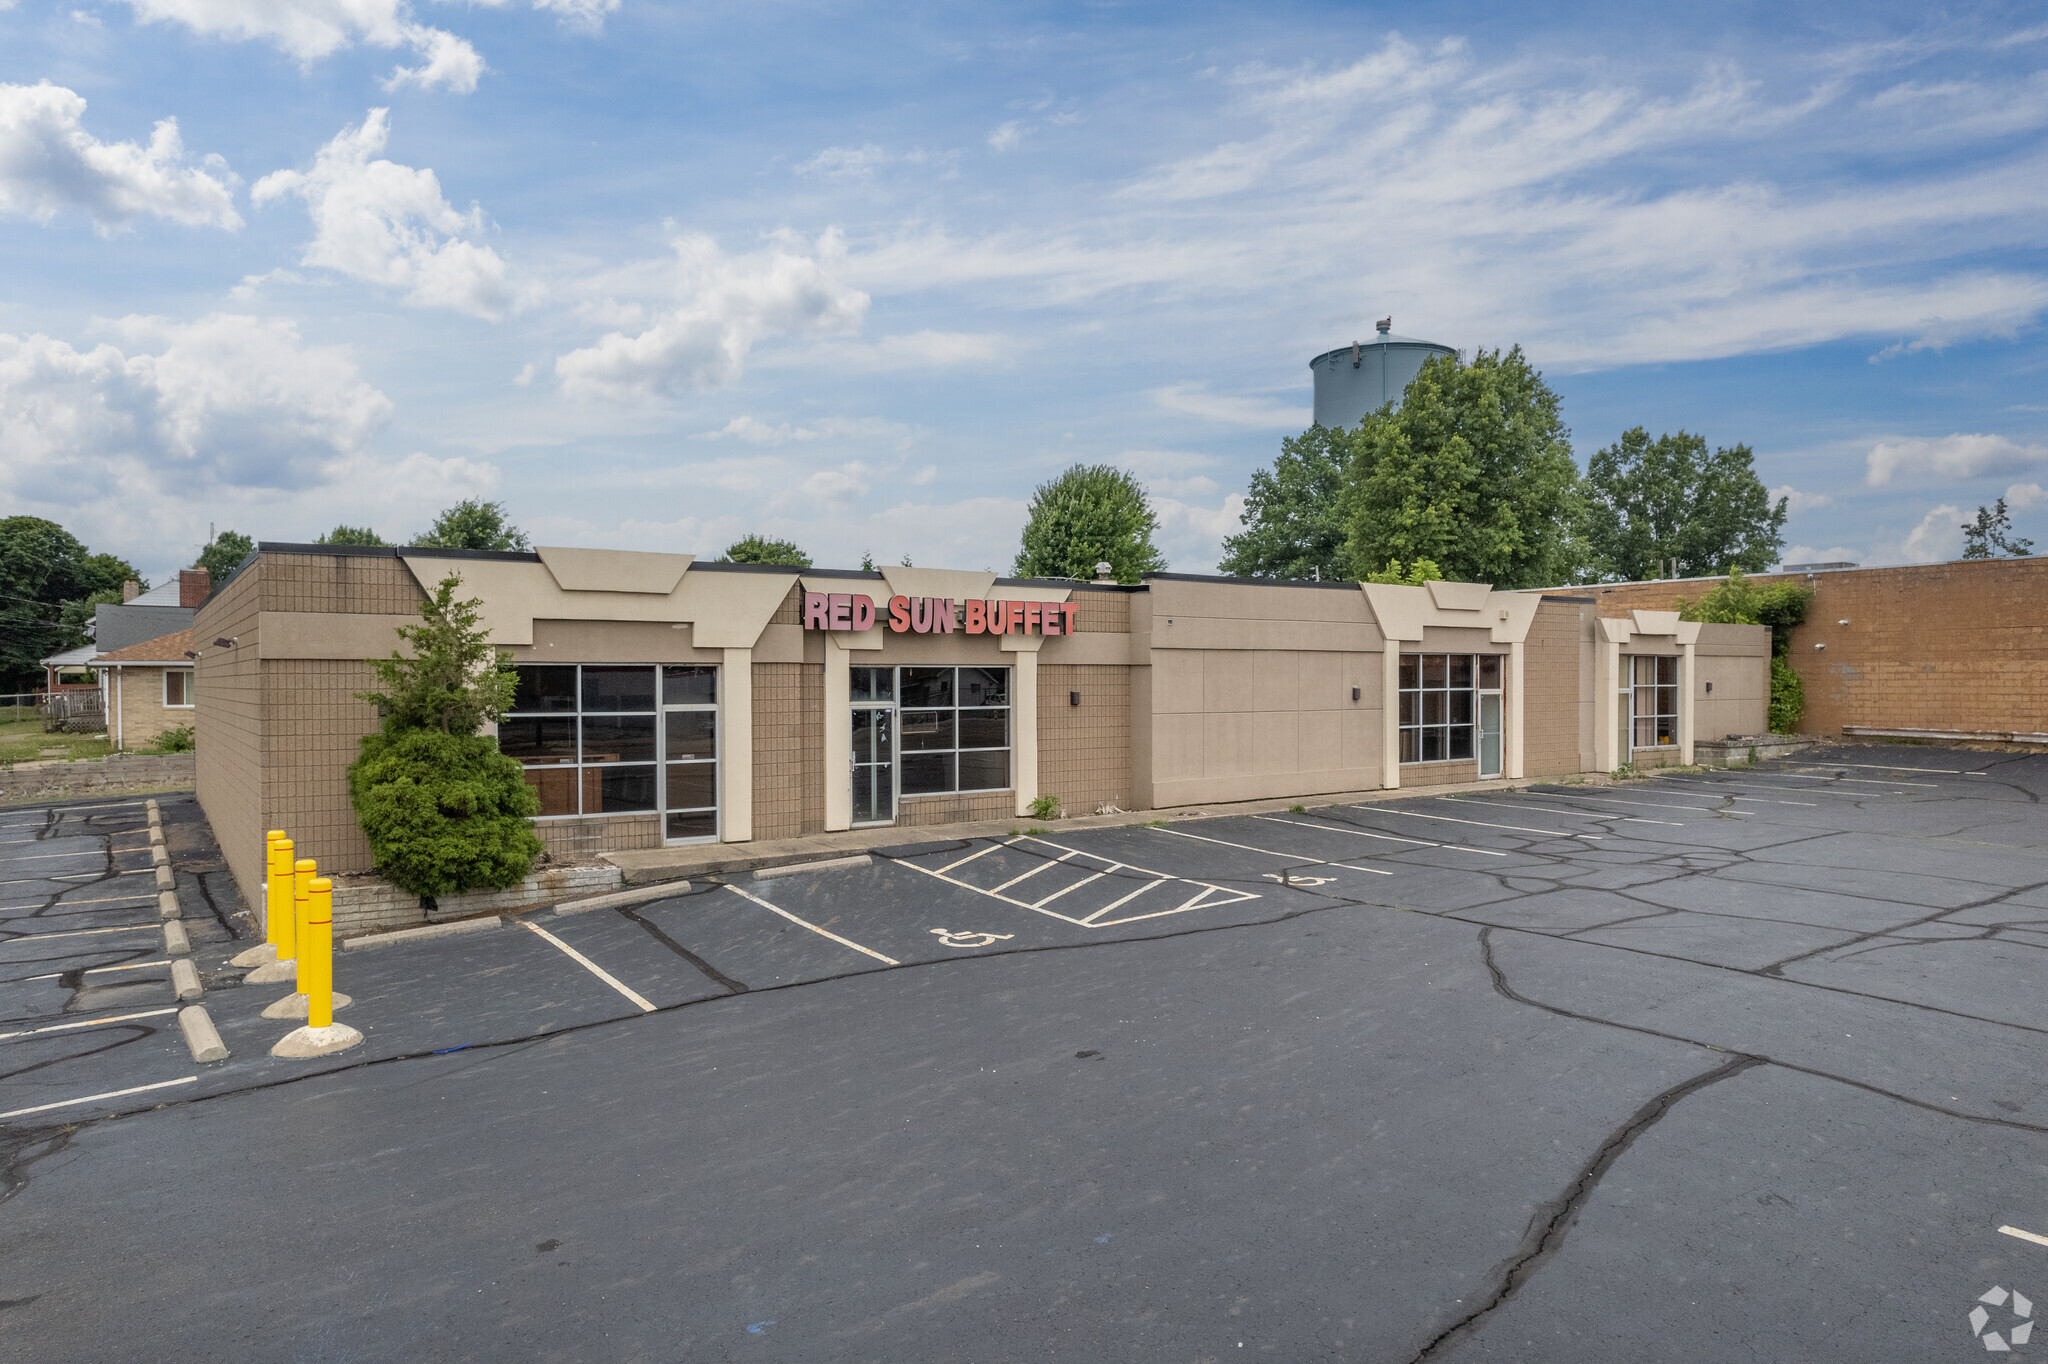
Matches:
[901,834,1260,928]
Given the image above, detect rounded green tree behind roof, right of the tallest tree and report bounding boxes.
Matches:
[1585,426,1786,582]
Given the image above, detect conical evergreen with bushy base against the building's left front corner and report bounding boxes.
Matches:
[348,576,541,895]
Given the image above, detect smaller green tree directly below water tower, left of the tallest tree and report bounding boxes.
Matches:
[1217,426,1352,582]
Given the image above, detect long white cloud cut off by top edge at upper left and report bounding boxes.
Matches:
[127,0,483,94]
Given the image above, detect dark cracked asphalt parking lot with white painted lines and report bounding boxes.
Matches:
[0,748,2048,1360]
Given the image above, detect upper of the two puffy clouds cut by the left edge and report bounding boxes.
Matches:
[0,80,242,236]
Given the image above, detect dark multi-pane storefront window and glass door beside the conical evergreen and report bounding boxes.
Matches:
[498,664,717,819]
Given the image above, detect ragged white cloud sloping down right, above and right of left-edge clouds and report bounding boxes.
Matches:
[250,109,510,319]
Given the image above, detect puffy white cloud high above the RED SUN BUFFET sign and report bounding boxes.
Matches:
[555,231,868,401]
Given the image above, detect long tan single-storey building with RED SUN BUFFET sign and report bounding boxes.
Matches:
[195,545,1769,913]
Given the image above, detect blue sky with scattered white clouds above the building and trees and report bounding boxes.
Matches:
[0,0,2048,578]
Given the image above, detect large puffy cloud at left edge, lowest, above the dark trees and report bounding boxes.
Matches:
[0,313,391,506]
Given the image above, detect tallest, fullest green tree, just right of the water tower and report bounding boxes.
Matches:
[1341,346,1581,588]
